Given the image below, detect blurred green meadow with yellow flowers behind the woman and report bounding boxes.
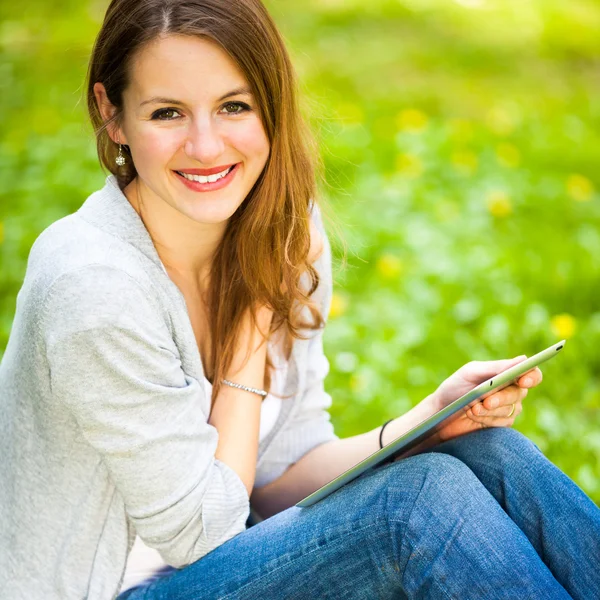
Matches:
[0,0,600,504]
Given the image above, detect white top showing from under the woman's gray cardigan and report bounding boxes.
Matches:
[119,368,287,594]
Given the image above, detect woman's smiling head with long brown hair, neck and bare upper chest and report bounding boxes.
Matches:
[88,1,322,400]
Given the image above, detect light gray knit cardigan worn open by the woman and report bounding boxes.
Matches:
[0,175,337,600]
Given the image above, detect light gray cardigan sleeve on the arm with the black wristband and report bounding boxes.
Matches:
[254,204,339,488]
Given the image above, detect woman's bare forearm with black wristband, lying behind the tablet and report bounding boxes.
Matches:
[251,395,438,518]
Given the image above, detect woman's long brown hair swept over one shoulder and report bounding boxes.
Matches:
[86,0,340,402]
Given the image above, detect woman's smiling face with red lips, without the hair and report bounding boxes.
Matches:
[96,36,269,223]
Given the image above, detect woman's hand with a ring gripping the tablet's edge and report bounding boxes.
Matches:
[434,355,542,442]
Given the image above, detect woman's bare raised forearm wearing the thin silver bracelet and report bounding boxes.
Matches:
[208,310,267,495]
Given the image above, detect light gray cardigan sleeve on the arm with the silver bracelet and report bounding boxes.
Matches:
[41,265,250,568]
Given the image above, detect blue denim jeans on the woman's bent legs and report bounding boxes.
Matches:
[118,428,600,600]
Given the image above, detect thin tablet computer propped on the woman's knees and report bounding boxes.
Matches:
[296,340,566,508]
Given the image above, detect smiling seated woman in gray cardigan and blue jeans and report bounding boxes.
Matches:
[0,0,600,600]
